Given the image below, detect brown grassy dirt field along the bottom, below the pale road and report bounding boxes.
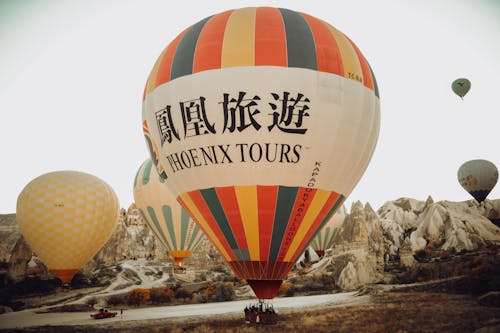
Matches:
[4,292,500,333]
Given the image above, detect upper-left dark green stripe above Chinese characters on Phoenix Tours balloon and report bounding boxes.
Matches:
[170,16,211,80]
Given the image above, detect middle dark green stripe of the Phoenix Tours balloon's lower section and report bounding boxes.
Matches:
[269,186,299,261]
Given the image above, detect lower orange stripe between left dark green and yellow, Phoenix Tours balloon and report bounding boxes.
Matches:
[215,186,248,249]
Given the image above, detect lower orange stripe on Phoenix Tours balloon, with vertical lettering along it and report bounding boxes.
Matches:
[277,187,316,261]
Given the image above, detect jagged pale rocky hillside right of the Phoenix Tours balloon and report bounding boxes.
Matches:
[286,197,500,290]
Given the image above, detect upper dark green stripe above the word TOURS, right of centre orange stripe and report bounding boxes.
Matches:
[279,8,318,70]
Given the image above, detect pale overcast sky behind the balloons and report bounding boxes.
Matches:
[0,0,500,213]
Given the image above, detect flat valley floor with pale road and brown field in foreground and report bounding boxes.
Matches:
[0,291,500,333]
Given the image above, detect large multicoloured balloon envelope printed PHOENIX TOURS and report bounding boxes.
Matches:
[142,7,380,299]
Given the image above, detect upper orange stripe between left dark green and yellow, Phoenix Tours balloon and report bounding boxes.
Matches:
[193,10,233,73]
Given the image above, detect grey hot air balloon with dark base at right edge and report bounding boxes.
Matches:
[457,160,498,202]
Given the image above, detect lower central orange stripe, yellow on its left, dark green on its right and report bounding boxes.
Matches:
[257,185,278,261]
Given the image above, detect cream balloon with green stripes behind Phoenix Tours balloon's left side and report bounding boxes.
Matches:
[134,159,204,266]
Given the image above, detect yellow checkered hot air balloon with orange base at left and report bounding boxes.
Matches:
[16,171,120,284]
